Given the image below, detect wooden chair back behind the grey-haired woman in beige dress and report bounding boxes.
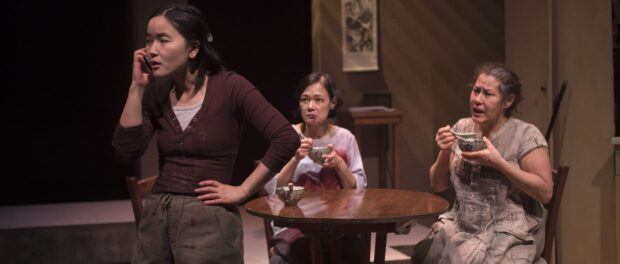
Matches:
[542,166,569,263]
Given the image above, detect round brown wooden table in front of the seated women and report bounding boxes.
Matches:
[245,189,448,264]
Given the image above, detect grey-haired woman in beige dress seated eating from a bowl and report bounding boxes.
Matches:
[412,63,553,263]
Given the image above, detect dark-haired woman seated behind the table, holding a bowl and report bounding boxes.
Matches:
[265,72,366,263]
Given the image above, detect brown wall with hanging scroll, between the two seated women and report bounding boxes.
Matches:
[313,0,504,190]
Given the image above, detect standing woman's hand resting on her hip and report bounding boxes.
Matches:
[194,180,248,205]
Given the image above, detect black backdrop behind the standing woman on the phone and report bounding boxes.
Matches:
[0,0,312,205]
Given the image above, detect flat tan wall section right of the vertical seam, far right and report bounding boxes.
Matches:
[552,0,616,263]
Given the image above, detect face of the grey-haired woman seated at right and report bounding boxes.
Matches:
[469,73,513,127]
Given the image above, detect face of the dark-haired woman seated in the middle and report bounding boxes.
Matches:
[299,82,336,126]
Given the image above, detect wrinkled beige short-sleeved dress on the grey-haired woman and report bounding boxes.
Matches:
[424,118,547,263]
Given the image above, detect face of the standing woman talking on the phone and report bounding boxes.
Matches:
[146,16,197,77]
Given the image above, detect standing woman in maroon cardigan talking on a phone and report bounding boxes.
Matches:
[112,4,299,263]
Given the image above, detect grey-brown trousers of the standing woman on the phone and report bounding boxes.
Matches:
[131,194,243,264]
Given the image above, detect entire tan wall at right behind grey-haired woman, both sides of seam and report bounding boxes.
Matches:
[506,0,616,263]
